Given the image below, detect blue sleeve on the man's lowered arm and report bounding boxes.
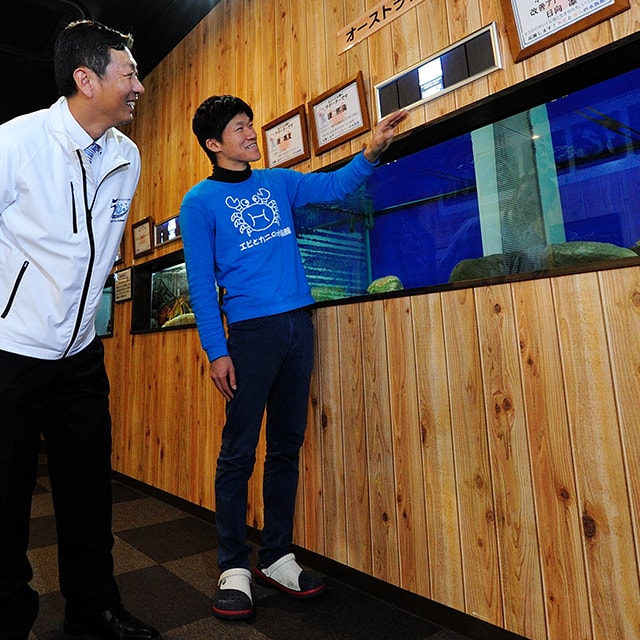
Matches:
[180,193,229,362]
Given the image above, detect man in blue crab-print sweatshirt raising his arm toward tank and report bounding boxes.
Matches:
[180,96,407,620]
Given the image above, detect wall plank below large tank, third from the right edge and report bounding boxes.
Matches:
[512,280,593,640]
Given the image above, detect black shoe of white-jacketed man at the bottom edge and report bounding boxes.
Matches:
[62,605,161,640]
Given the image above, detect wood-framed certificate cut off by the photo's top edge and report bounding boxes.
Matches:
[500,0,629,62]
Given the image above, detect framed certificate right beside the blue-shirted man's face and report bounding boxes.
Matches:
[262,105,311,168]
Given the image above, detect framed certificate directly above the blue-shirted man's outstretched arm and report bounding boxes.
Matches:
[309,71,371,155]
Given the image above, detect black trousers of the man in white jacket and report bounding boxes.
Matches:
[0,339,120,640]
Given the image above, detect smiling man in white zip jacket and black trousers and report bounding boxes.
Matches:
[0,21,159,640]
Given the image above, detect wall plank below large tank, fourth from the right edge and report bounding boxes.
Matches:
[475,285,545,638]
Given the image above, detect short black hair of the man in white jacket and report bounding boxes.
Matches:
[53,20,133,97]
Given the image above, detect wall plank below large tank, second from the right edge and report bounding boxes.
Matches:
[553,273,640,640]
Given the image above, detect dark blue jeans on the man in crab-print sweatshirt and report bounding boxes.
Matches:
[216,309,313,571]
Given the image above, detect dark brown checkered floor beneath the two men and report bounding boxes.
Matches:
[29,454,490,640]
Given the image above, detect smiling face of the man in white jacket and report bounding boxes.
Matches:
[92,48,144,129]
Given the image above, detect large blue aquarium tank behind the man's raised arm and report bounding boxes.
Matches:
[296,58,640,301]
